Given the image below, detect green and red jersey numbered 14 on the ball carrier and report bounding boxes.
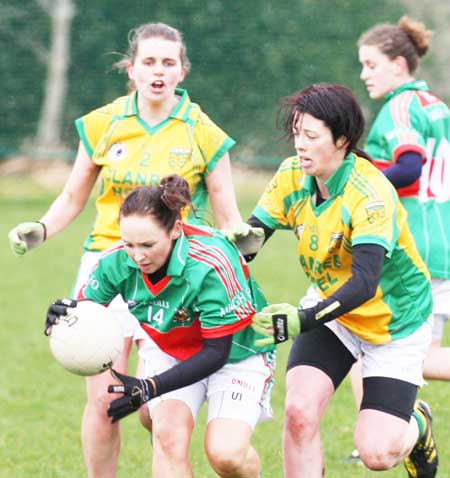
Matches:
[80,225,273,362]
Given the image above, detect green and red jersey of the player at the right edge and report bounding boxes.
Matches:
[366,81,450,279]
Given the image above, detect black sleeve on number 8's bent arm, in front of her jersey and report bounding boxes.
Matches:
[299,244,386,332]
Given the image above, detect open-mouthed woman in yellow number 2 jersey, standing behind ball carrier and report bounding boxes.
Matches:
[9,23,241,478]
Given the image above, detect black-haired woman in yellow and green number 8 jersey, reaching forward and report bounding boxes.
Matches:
[244,84,437,478]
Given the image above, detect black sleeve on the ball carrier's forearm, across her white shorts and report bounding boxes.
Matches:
[151,335,233,395]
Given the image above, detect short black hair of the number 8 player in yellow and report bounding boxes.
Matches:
[278,83,370,159]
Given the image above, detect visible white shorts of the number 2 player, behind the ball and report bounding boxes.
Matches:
[72,252,147,340]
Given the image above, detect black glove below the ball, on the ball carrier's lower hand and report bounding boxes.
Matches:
[108,369,156,423]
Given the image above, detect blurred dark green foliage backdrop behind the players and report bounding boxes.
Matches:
[0,0,404,166]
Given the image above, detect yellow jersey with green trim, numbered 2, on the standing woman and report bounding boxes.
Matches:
[75,89,235,251]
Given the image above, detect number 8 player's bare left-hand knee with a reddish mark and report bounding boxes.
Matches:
[285,400,320,439]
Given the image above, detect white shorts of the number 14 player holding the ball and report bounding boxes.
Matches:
[139,339,275,429]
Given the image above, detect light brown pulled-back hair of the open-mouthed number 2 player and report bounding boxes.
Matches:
[113,23,191,92]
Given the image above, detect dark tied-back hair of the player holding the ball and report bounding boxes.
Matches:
[119,174,192,231]
